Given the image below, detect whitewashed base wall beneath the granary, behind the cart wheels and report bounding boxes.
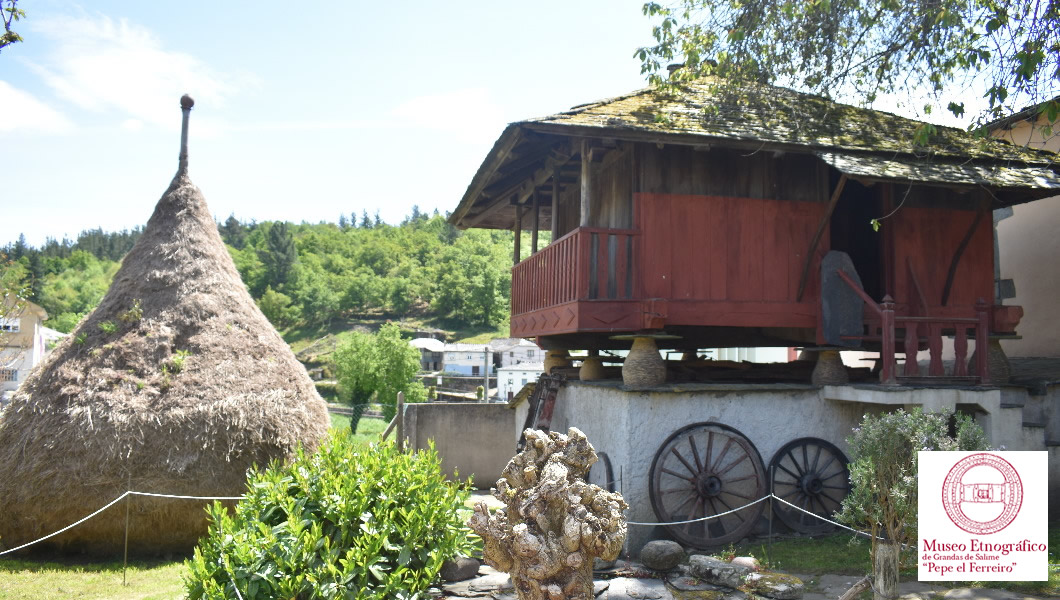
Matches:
[552,382,1057,552]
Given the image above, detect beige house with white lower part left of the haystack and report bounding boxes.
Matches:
[0,296,48,402]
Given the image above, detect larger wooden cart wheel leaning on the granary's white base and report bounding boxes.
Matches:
[648,423,767,548]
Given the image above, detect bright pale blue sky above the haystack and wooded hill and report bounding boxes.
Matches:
[0,0,651,245]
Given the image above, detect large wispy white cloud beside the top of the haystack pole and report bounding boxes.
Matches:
[27,16,246,128]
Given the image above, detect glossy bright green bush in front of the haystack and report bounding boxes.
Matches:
[186,433,473,600]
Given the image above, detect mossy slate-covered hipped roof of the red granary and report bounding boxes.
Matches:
[449,80,1060,228]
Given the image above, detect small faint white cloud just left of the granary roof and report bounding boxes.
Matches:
[390,88,506,142]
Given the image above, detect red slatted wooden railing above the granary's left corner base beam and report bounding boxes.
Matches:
[512,227,637,315]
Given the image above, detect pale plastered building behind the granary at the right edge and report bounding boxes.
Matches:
[987,96,1060,357]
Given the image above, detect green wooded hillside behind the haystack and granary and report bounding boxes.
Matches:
[0,210,512,331]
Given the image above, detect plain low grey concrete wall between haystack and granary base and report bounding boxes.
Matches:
[405,402,517,490]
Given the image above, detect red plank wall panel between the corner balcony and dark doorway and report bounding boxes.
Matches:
[635,194,828,303]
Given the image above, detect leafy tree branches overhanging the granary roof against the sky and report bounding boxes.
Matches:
[636,0,1060,121]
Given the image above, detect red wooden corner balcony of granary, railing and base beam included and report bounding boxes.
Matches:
[511,227,641,337]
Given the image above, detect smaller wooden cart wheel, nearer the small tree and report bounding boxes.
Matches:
[770,438,850,533]
